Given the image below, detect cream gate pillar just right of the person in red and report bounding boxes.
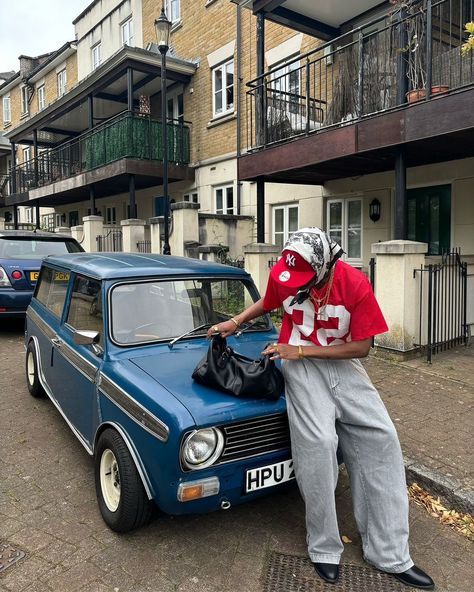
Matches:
[372,240,428,352]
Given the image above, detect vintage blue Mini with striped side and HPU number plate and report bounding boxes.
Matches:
[25,253,294,532]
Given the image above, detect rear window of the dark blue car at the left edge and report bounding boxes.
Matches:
[0,237,82,260]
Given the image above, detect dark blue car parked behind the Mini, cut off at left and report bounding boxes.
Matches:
[0,230,84,318]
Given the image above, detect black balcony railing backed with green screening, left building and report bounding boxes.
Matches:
[11,111,190,193]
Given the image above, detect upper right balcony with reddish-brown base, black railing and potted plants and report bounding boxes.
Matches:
[239,0,474,183]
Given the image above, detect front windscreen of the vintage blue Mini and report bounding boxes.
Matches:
[110,278,270,345]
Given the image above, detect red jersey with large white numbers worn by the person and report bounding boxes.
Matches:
[263,261,388,346]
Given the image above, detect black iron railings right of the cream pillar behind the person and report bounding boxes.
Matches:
[413,248,469,363]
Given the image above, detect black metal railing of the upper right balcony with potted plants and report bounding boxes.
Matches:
[246,0,474,150]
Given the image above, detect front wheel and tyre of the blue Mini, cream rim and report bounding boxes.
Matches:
[95,429,153,532]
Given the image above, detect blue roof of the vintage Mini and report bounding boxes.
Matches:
[44,253,249,279]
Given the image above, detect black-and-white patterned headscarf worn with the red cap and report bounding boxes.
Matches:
[283,226,344,284]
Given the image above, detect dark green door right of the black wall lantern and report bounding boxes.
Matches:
[407,185,451,255]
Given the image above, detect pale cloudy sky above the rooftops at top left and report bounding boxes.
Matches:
[0,0,92,72]
